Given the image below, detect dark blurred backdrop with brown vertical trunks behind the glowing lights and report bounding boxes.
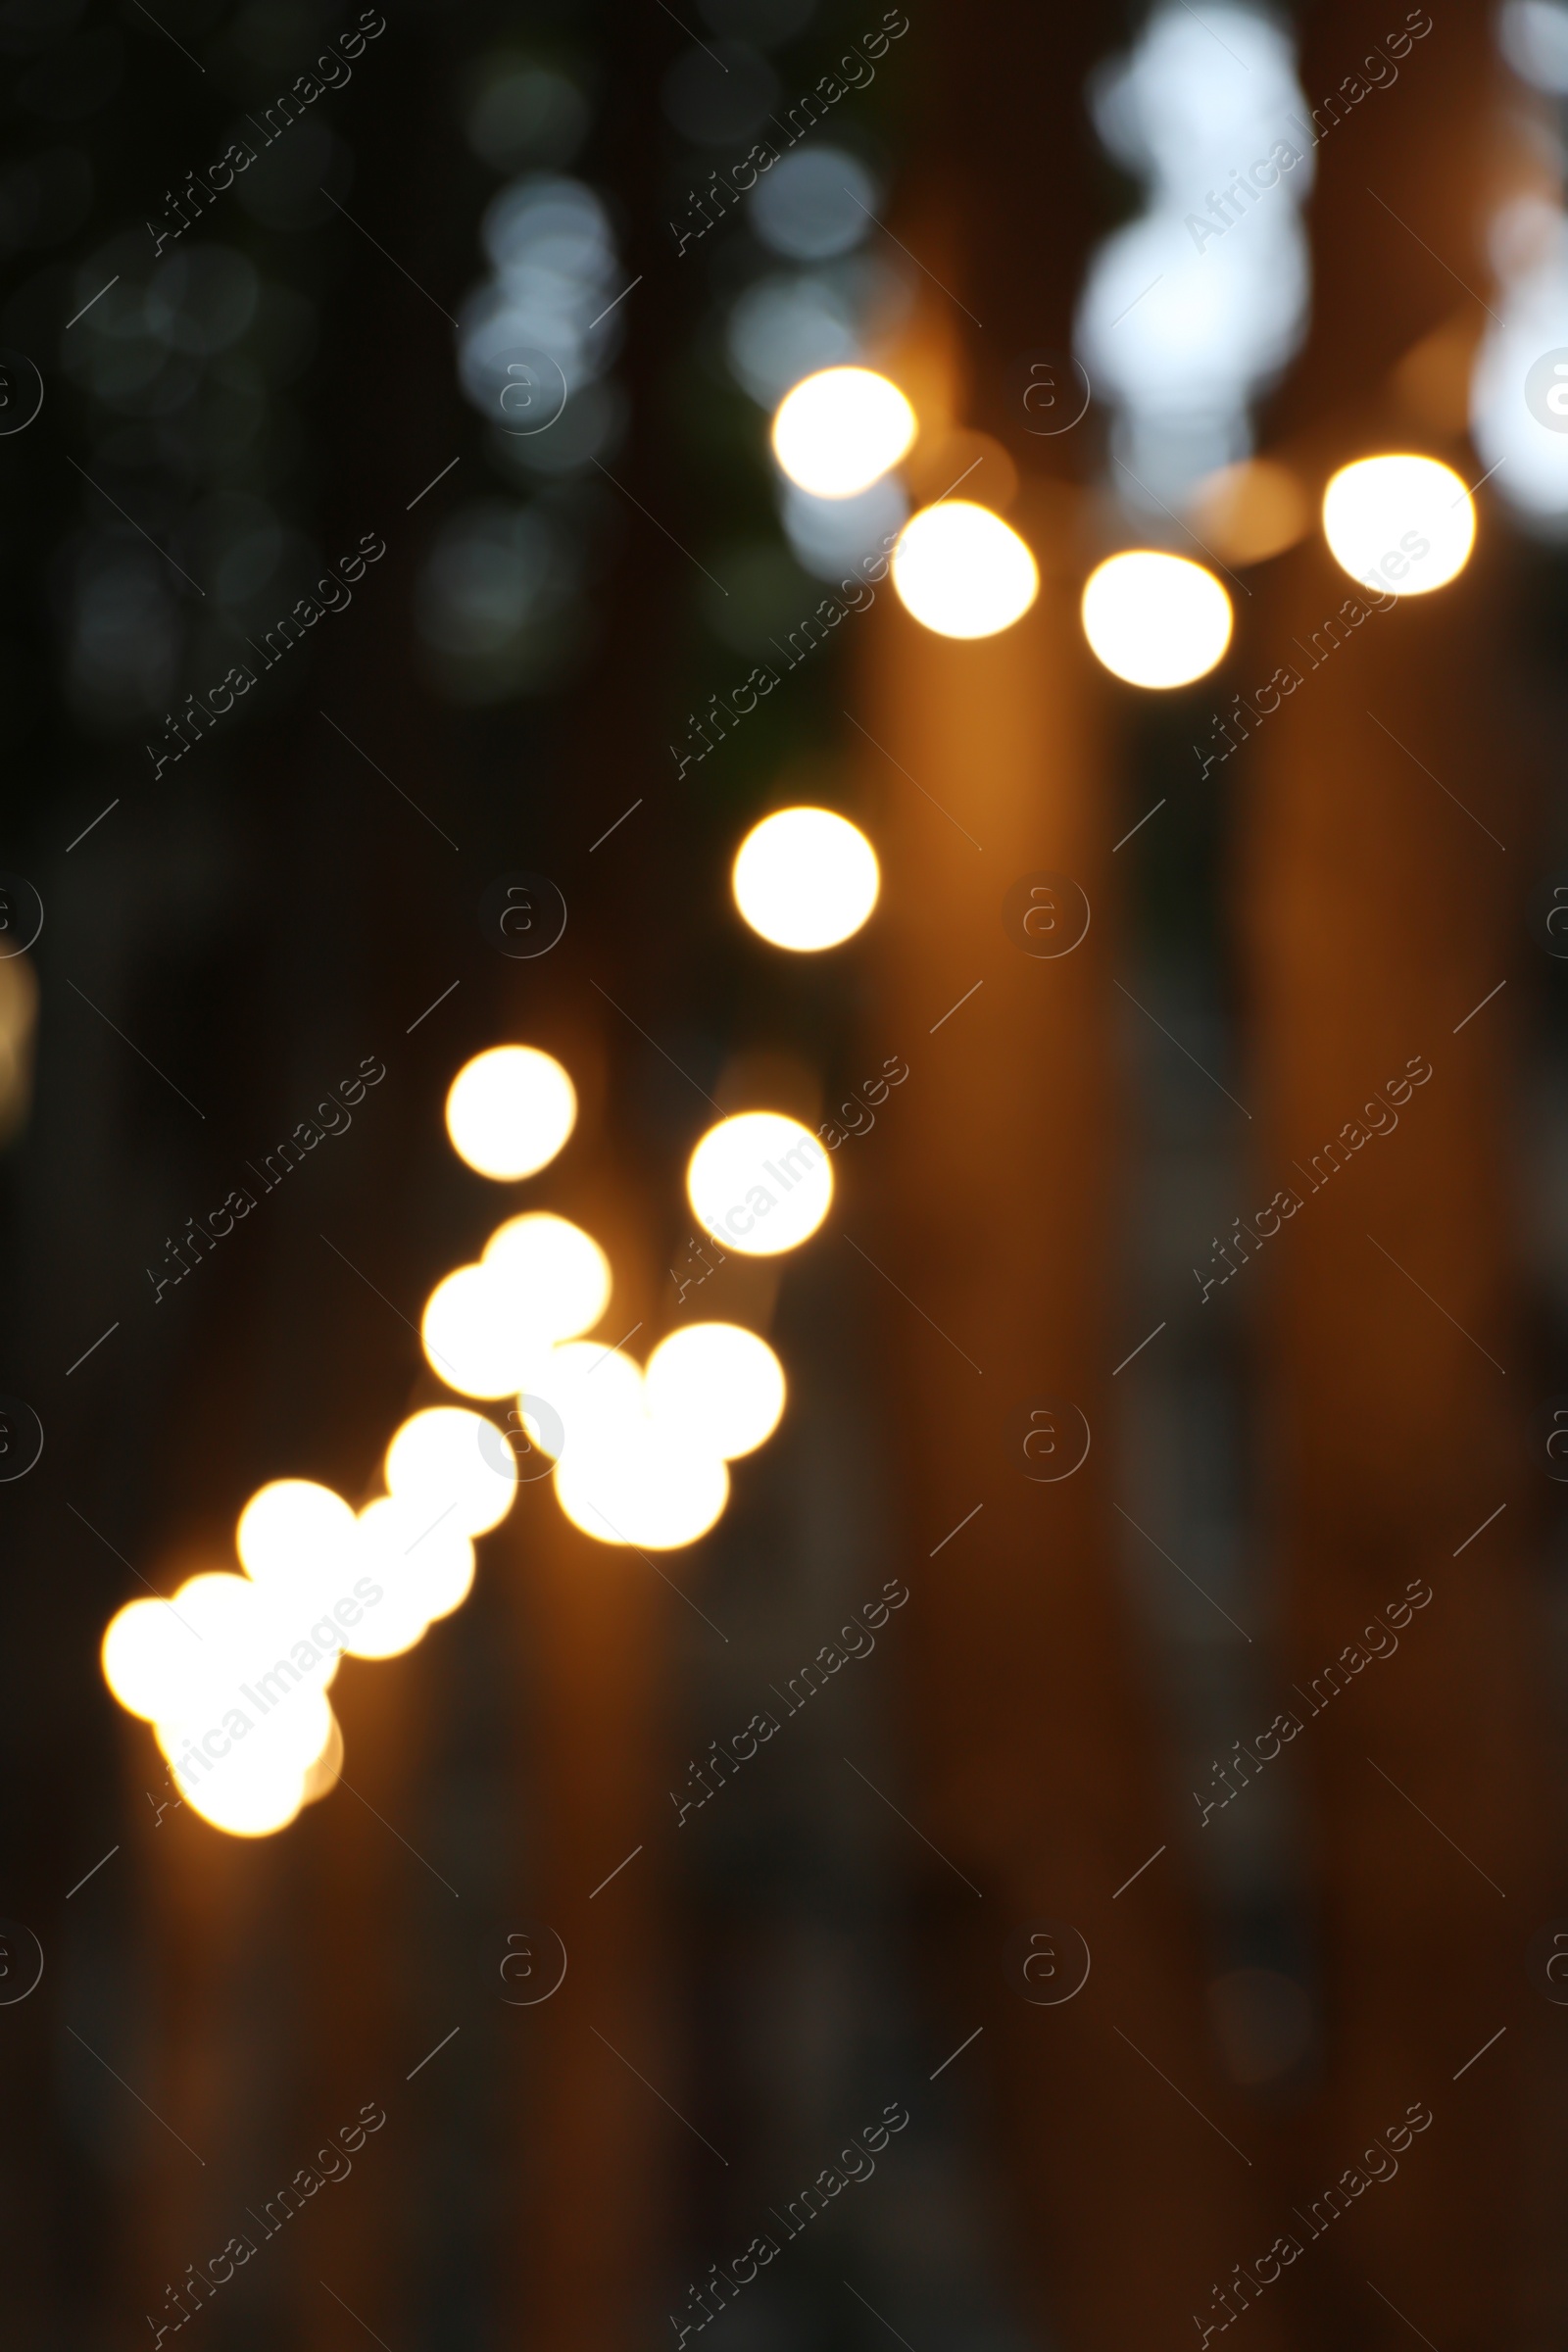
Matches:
[0,0,1568,2352]
